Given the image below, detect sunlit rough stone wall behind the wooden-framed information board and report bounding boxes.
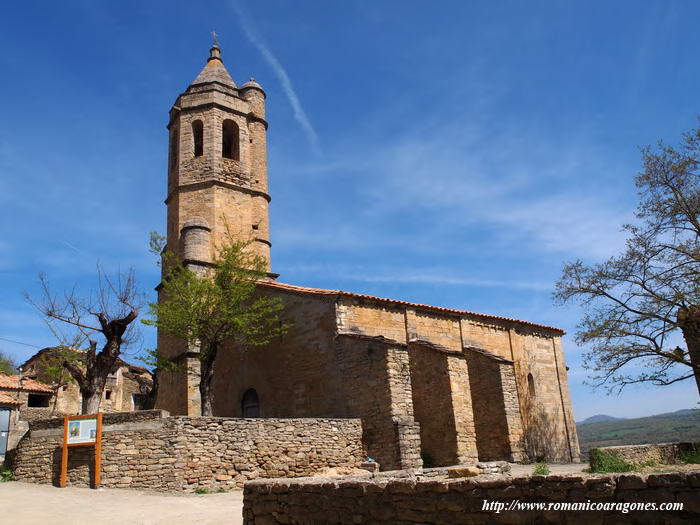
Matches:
[12,410,364,492]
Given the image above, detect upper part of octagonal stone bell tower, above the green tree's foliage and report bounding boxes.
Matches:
[165,43,271,271]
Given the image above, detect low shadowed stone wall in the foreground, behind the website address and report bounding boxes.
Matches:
[243,471,700,525]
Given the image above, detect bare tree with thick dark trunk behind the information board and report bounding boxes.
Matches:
[26,265,143,414]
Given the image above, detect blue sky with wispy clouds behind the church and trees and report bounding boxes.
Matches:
[0,1,700,419]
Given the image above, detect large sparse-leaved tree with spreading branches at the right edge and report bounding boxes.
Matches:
[554,128,700,392]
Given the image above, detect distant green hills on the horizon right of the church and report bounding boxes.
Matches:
[576,409,700,459]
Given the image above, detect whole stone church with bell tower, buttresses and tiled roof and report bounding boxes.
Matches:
[157,45,579,470]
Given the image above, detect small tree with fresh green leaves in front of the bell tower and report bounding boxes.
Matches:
[143,239,287,416]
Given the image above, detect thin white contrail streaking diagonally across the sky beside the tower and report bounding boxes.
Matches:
[231,0,321,156]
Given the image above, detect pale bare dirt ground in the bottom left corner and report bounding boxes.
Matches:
[0,481,243,525]
